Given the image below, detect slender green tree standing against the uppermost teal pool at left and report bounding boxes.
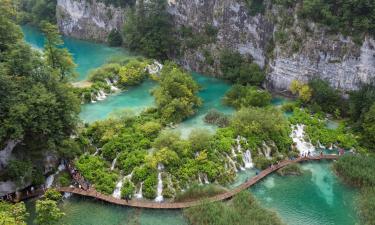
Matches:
[42,22,76,80]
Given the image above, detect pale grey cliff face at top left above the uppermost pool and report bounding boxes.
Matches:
[56,0,125,41]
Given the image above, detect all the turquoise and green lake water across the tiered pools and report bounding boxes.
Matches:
[23,26,358,225]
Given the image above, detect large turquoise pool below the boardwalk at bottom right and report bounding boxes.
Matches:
[251,162,358,225]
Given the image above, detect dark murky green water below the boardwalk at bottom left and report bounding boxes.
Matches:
[26,197,187,225]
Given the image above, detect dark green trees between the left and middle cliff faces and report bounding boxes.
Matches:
[124,0,176,60]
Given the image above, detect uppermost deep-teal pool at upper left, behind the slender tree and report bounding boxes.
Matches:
[22,26,132,81]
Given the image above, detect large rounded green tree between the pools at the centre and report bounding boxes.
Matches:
[153,63,202,123]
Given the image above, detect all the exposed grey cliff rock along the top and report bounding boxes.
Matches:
[57,0,375,91]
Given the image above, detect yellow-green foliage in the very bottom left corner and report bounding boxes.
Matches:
[0,201,29,225]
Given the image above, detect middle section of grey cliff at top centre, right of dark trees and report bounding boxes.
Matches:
[169,0,273,74]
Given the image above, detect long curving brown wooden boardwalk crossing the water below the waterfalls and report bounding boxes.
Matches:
[57,155,339,209]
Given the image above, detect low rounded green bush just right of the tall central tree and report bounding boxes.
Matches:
[223,85,272,109]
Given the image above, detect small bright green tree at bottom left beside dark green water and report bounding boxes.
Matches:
[35,199,65,225]
